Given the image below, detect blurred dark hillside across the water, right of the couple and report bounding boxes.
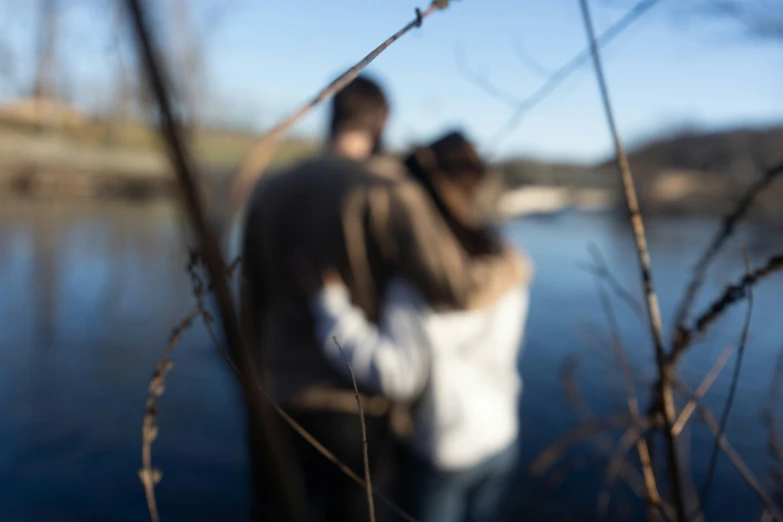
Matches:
[498,126,783,219]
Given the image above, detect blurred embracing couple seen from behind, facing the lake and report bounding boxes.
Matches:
[243,76,532,522]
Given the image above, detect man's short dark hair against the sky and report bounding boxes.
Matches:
[329,75,389,136]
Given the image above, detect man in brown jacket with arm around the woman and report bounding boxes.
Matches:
[243,77,524,522]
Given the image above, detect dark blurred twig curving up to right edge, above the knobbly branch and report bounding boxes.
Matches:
[673,163,783,350]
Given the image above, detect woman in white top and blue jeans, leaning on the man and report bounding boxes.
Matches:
[312,133,530,522]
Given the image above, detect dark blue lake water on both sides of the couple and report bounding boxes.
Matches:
[0,197,783,522]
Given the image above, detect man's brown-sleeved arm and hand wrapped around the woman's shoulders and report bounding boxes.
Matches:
[368,180,532,309]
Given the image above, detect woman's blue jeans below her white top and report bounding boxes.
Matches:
[399,443,518,522]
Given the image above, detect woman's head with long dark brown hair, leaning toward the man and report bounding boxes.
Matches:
[405,132,498,255]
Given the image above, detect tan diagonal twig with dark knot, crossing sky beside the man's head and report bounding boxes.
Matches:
[228,0,449,209]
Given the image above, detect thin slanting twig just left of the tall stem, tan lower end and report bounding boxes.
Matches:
[590,245,661,507]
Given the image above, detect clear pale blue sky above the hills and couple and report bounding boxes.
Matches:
[1,0,783,161]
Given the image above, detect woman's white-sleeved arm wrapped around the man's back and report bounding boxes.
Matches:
[311,283,430,401]
